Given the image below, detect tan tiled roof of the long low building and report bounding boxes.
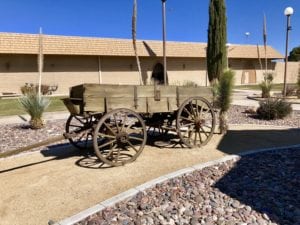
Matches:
[0,33,283,59]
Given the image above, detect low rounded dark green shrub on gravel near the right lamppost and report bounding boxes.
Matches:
[256,98,292,120]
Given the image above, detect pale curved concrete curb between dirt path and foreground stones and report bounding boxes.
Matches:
[53,144,300,225]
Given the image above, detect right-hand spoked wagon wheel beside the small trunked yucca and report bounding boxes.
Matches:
[176,97,215,148]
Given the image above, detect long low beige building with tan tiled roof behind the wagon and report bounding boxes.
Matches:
[0,33,298,94]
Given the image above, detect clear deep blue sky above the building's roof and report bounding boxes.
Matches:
[0,0,300,53]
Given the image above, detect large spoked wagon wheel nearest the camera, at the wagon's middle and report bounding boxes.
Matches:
[93,109,147,166]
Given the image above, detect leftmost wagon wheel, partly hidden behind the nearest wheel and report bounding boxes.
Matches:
[66,115,95,149]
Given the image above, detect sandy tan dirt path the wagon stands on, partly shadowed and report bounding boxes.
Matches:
[0,126,300,225]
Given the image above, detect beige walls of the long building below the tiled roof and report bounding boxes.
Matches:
[0,54,299,94]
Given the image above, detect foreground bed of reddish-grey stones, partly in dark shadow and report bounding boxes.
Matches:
[76,148,300,225]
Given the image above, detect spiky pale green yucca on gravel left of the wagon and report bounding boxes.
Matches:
[19,92,50,129]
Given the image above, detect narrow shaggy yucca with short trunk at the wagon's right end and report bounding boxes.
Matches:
[217,70,234,134]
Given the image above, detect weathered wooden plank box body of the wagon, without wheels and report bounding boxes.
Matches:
[70,84,212,113]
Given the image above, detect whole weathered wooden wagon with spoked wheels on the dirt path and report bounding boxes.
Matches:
[64,84,215,166]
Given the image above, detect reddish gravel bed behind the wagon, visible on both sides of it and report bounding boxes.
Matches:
[0,106,300,152]
